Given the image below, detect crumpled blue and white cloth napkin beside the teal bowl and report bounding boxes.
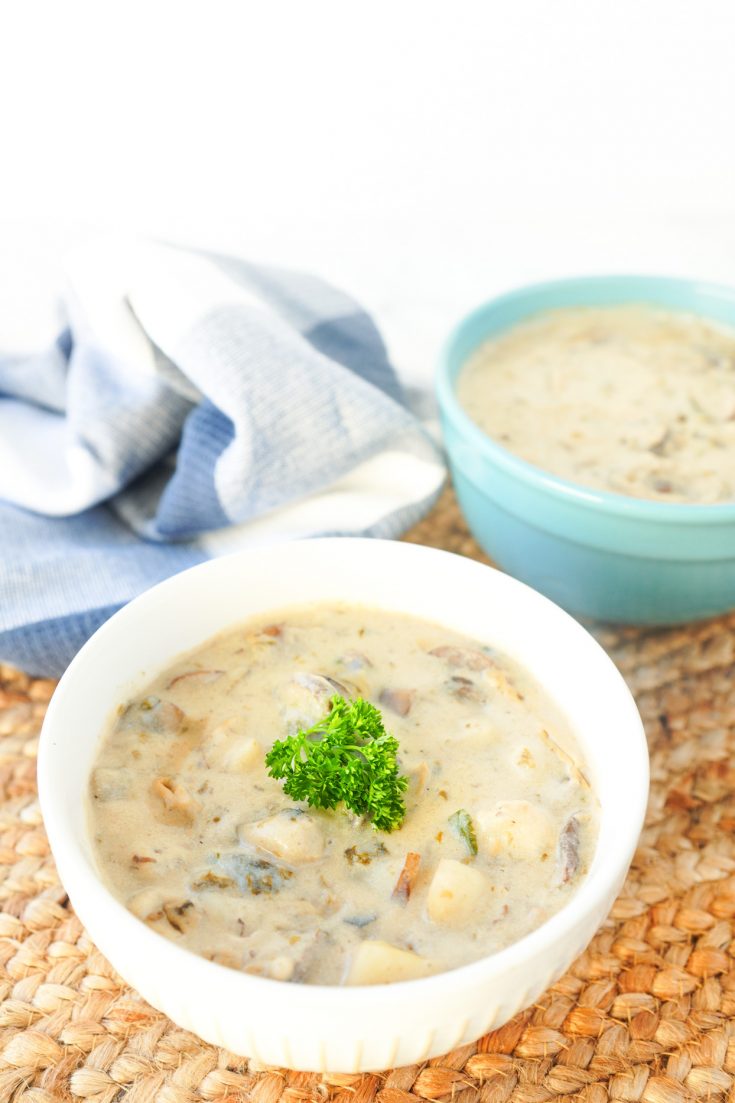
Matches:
[0,243,444,675]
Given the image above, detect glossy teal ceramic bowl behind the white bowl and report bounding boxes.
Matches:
[437,276,735,624]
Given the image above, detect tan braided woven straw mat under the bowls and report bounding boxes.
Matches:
[0,493,735,1103]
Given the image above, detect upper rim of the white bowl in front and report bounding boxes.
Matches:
[38,537,650,1014]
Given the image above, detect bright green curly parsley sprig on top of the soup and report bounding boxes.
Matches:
[265,694,408,832]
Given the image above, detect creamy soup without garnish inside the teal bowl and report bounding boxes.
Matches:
[458,306,735,504]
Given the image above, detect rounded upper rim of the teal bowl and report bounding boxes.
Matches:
[435,272,735,525]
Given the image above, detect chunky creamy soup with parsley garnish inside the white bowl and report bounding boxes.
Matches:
[89,606,598,984]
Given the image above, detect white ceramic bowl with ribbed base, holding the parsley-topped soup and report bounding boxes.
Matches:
[39,538,648,1072]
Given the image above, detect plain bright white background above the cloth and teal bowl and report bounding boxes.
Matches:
[0,0,735,390]
